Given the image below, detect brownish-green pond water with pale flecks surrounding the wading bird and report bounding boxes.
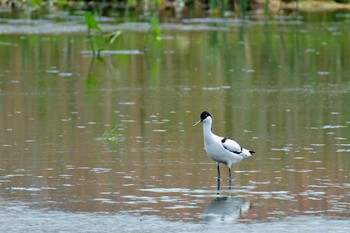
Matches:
[0,11,350,232]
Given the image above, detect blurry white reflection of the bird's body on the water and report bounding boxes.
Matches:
[204,196,250,223]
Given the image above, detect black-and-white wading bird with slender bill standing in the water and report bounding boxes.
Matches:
[193,111,255,189]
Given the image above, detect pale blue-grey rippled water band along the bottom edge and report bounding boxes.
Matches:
[0,203,349,233]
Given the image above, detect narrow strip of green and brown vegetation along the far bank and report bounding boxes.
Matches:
[0,0,350,17]
